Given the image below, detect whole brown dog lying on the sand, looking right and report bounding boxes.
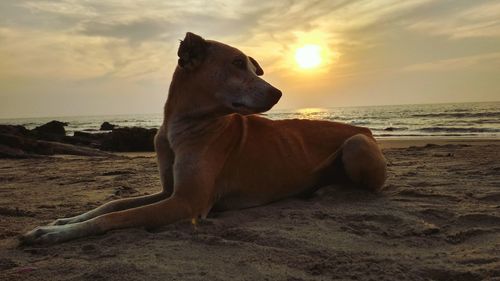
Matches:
[21,33,386,244]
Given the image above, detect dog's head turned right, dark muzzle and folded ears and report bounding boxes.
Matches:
[177,32,281,114]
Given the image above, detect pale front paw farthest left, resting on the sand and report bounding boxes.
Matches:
[19,226,68,245]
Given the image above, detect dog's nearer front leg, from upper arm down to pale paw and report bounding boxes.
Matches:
[20,150,223,244]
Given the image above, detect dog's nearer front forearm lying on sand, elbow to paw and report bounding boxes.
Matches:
[20,196,193,245]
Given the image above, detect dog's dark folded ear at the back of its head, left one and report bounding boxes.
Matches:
[177,32,208,69]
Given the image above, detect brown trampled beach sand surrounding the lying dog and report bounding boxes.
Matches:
[0,140,500,281]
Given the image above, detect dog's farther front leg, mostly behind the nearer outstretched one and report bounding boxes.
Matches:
[50,126,174,225]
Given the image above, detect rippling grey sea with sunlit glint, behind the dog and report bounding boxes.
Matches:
[0,102,500,139]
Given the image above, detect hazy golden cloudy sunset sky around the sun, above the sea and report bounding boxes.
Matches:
[0,0,500,118]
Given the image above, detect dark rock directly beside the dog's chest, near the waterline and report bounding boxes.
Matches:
[101,127,157,151]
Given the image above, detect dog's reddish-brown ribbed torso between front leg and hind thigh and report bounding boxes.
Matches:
[212,114,371,208]
